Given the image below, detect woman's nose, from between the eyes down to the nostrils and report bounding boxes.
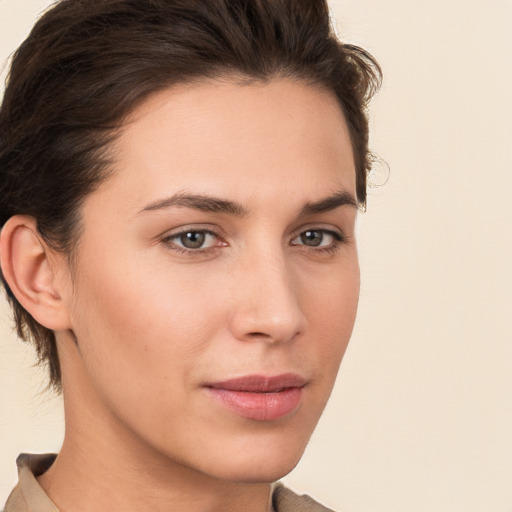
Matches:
[230,251,307,344]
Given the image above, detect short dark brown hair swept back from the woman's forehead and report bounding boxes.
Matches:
[0,0,381,389]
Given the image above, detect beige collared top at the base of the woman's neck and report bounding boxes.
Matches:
[4,453,334,512]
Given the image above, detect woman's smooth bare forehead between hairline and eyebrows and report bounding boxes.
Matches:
[87,80,355,216]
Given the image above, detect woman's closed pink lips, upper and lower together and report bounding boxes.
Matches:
[204,373,307,421]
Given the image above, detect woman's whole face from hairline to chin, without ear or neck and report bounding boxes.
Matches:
[59,80,359,481]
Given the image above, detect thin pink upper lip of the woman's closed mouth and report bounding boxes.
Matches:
[206,373,307,393]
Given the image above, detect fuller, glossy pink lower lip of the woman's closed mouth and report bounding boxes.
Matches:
[206,387,302,421]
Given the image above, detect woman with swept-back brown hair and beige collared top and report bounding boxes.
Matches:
[0,0,380,512]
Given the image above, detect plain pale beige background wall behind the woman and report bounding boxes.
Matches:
[0,0,512,512]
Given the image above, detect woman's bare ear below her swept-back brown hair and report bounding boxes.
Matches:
[0,215,69,331]
